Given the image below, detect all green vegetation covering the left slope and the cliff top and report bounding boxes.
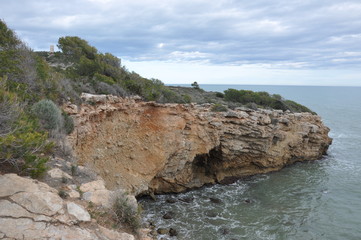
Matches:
[0,20,310,177]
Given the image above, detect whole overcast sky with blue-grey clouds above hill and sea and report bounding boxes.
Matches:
[0,0,361,86]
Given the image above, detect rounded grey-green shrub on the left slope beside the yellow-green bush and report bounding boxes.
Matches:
[32,99,63,130]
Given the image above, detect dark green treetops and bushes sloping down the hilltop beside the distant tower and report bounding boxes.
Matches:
[56,36,188,102]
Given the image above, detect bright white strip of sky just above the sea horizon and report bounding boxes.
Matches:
[123,60,361,86]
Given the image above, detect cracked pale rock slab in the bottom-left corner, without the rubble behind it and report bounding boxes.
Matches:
[0,174,135,240]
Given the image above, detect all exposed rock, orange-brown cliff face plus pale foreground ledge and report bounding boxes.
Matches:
[0,94,332,240]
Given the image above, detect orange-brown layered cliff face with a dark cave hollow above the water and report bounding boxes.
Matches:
[64,95,332,194]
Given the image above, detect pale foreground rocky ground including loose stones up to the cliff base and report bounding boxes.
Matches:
[0,158,153,240]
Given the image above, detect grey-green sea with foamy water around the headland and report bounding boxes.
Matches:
[140,85,361,240]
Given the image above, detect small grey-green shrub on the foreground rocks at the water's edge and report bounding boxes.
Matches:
[113,194,141,232]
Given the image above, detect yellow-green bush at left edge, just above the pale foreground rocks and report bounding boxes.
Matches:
[0,79,53,177]
